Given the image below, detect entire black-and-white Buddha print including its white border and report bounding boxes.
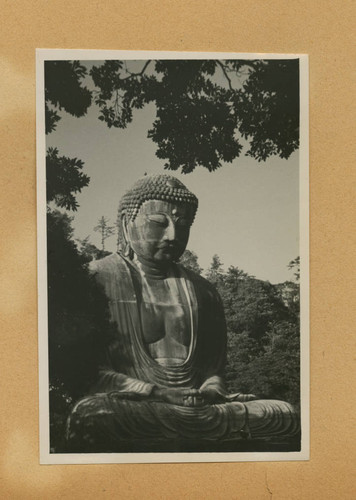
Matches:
[37,49,309,464]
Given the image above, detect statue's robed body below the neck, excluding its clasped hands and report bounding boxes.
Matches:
[67,254,298,451]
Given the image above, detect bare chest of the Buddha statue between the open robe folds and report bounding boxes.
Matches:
[140,278,191,362]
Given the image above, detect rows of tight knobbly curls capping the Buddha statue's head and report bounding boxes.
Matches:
[118,174,198,249]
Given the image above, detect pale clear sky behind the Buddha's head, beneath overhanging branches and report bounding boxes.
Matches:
[46,60,299,283]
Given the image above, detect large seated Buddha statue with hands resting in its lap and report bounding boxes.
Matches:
[67,175,299,453]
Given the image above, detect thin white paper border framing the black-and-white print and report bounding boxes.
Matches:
[36,49,310,464]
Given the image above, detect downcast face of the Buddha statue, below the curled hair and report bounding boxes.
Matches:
[126,200,193,263]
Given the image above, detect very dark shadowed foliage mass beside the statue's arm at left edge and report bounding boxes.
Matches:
[47,210,112,451]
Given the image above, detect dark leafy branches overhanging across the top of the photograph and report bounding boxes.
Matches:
[46,59,299,173]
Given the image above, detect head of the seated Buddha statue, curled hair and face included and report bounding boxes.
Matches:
[119,174,198,264]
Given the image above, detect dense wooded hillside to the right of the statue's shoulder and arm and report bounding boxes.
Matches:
[206,255,300,406]
